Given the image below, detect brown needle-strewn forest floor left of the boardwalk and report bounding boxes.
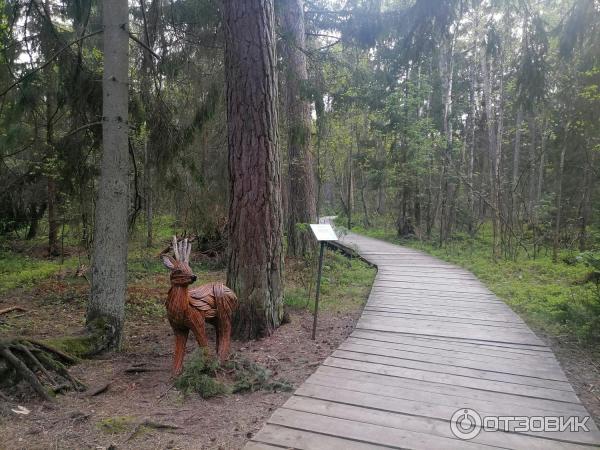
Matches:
[0,237,375,450]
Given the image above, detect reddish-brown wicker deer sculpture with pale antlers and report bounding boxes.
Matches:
[162,236,238,375]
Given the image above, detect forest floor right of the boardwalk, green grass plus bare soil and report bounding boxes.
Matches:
[350,219,600,426]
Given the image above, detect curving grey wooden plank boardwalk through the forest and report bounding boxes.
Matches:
[246,230,600,450]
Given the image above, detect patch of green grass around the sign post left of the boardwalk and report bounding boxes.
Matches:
[285,249,376,312]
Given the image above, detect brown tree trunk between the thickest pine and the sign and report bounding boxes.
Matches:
[281,0,317,256]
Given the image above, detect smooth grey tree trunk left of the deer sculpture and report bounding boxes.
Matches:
[86,0,129,350]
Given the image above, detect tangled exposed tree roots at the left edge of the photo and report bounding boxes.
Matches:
[0,338,85,401]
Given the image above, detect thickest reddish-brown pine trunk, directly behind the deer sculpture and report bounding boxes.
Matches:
[224,0,283,339]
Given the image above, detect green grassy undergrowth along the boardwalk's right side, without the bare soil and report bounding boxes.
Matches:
[344,221,600,346]
